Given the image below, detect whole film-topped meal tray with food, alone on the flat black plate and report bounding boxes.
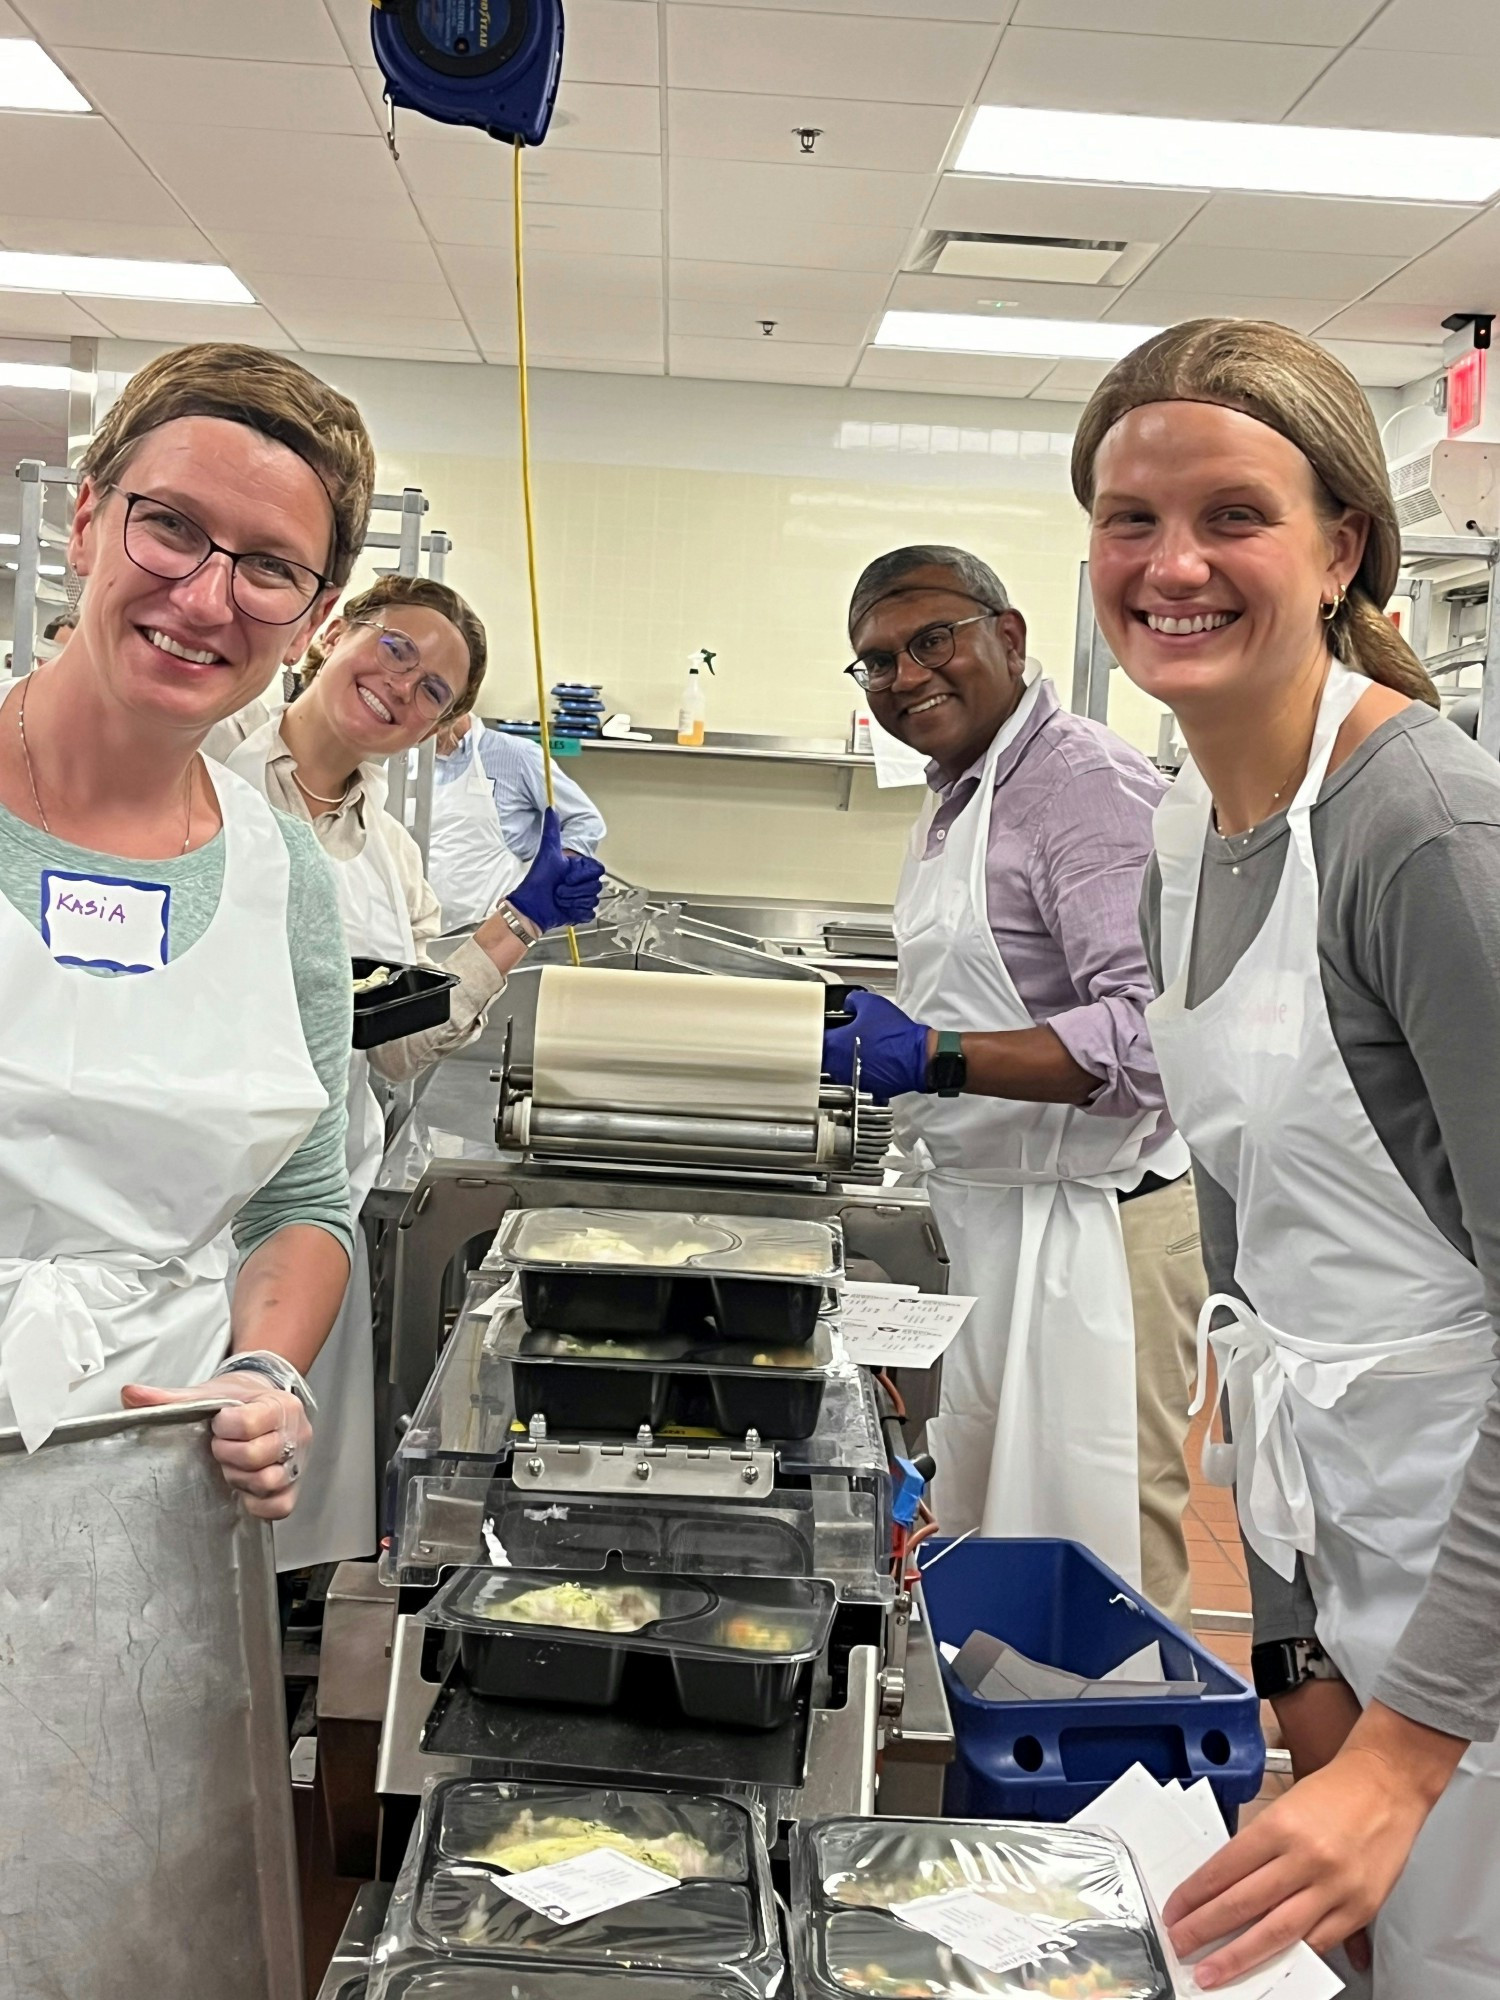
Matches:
[428,1568,834,1730]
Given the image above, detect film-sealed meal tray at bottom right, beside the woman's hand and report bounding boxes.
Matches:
[792,1818,1172,2000]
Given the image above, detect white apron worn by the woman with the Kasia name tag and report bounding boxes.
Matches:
[0,764,328,1450]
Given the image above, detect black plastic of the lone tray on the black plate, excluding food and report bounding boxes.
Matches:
[430,1568,836,1730]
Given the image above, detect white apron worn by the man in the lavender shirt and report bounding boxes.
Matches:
[894,684,1186,1588]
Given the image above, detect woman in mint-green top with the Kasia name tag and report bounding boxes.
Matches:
[0,344,374,1518]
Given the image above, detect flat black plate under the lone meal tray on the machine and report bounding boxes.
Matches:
[422,1668,812,1790]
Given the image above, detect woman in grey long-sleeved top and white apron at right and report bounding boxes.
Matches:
[1074,320,1500,2000]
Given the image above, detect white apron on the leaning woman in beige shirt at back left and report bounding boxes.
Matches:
[228,716,416,1570]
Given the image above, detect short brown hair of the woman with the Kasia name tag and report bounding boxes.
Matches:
[78,340,374,586]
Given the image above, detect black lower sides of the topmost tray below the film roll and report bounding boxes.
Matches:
[520,1266,826,1348]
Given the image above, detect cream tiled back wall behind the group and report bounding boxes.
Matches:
[100,344,1158,902]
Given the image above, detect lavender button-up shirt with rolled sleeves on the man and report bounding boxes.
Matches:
[924,680,1172,1150]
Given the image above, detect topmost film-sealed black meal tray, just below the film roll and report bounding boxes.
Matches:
[494,1208,844,1346]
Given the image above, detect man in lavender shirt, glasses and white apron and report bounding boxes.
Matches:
[824,546,1206,1622]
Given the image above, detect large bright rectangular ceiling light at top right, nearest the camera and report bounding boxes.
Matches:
[956,104,1500,202]
